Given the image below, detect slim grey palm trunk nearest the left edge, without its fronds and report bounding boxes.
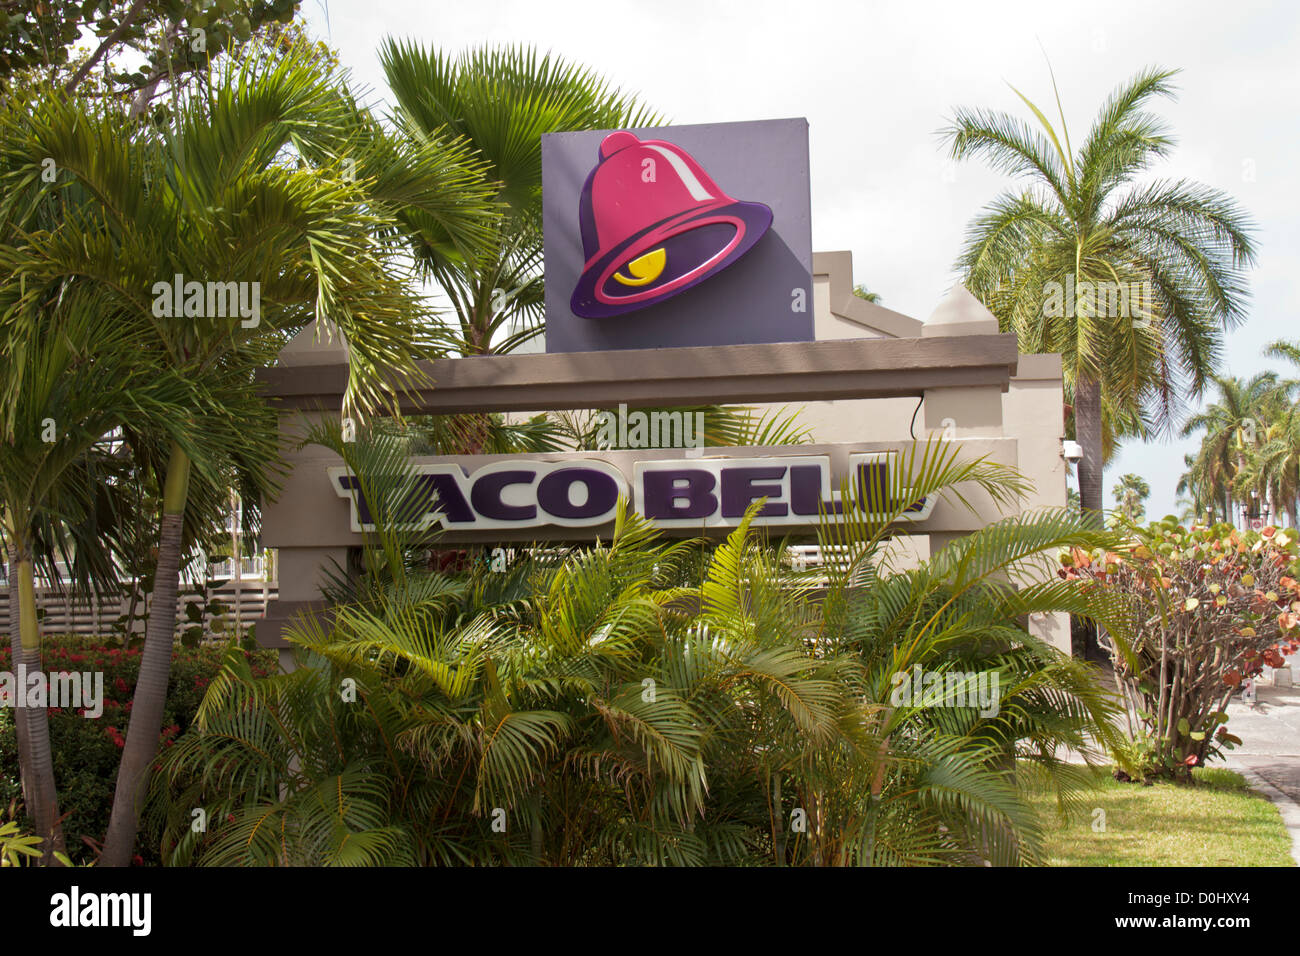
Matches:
[14,542,64,866]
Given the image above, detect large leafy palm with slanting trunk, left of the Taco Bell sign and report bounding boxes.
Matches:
[2,39,495,865]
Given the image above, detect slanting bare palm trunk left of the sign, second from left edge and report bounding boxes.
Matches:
[99,442,190,866]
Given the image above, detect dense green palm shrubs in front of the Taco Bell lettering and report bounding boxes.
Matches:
[148,514,1118,866]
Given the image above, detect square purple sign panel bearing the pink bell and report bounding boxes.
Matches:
[542,120,814,352]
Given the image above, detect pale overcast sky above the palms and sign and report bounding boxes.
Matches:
[303,0,1300,515]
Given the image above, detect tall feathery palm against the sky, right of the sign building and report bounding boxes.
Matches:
[943,68,1255,522]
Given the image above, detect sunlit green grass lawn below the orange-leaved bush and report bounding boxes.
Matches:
[1034,767,1295,866]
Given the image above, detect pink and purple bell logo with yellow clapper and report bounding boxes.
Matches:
[569,133,772,319]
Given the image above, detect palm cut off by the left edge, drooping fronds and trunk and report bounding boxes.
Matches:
[0,277,228,862]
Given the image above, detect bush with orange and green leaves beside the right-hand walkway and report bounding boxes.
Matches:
[1060,518,1300,778]
